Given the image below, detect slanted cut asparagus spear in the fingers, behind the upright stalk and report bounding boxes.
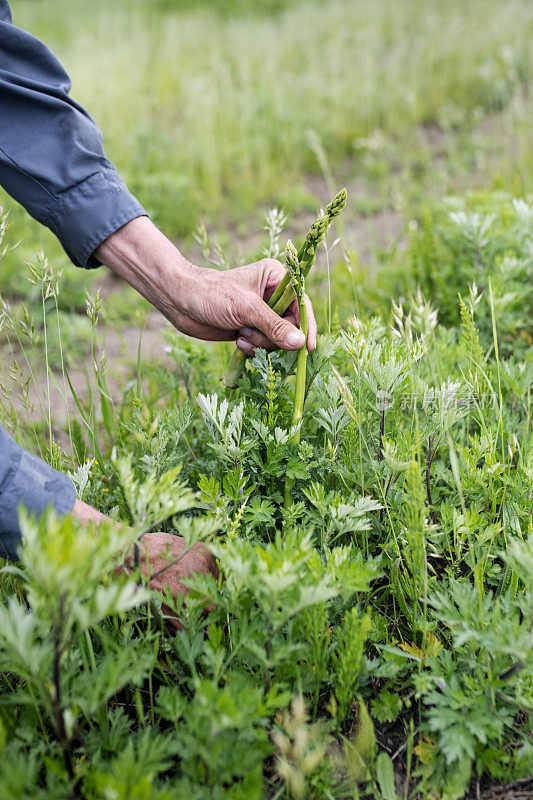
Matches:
[222,189,346,389]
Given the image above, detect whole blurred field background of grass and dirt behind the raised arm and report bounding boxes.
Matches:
[0,0,533,396]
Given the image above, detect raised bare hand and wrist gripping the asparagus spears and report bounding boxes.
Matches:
[95,217,316,355]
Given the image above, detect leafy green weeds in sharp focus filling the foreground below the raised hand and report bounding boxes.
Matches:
[0,191,533,800]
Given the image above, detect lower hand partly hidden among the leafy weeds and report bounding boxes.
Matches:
[71,500,218,628]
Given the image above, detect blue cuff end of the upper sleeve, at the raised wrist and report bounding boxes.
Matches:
[45,166,148,268]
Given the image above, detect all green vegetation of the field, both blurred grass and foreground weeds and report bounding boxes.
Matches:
[0,0,533,800]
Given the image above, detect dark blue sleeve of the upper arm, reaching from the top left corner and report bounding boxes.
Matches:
[0,0,146,267]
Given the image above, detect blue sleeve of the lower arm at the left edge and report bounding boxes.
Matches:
[0,426,76,561]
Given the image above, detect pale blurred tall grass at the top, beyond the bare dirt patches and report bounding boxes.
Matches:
[6,0,533,268]
